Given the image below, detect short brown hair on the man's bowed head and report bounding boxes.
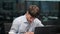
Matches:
[28,5,39,17]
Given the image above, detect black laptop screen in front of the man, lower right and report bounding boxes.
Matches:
[34,26,57,34]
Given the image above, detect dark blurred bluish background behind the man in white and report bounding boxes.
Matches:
[0,0,60,34]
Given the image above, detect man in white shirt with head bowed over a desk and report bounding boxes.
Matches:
[9,5,44,34]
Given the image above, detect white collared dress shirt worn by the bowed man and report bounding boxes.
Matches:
[9,15,44,34]
